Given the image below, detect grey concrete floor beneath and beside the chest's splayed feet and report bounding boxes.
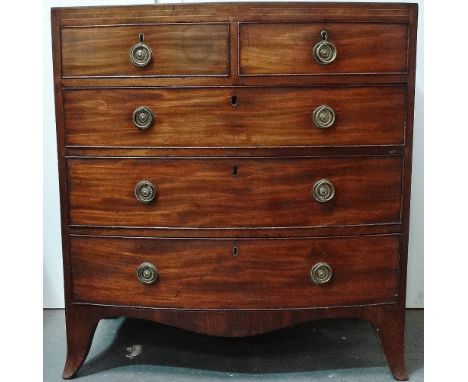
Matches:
[44,309,424,382]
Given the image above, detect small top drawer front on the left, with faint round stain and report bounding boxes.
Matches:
[61,23,229,77]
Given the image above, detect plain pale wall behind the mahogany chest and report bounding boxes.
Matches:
[43,0,424,308]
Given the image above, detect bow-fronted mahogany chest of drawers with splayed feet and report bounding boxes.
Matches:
[52,3,417,380]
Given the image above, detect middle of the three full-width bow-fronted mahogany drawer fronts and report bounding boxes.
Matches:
[68,157,402,228]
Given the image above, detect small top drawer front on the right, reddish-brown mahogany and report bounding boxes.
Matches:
[239,23,408,75]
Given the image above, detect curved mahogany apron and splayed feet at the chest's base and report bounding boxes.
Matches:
[63,303,408,381]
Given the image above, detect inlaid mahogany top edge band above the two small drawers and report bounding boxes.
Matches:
[60,1,414,26]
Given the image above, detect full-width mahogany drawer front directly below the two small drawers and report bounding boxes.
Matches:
[64,86,406,147]
